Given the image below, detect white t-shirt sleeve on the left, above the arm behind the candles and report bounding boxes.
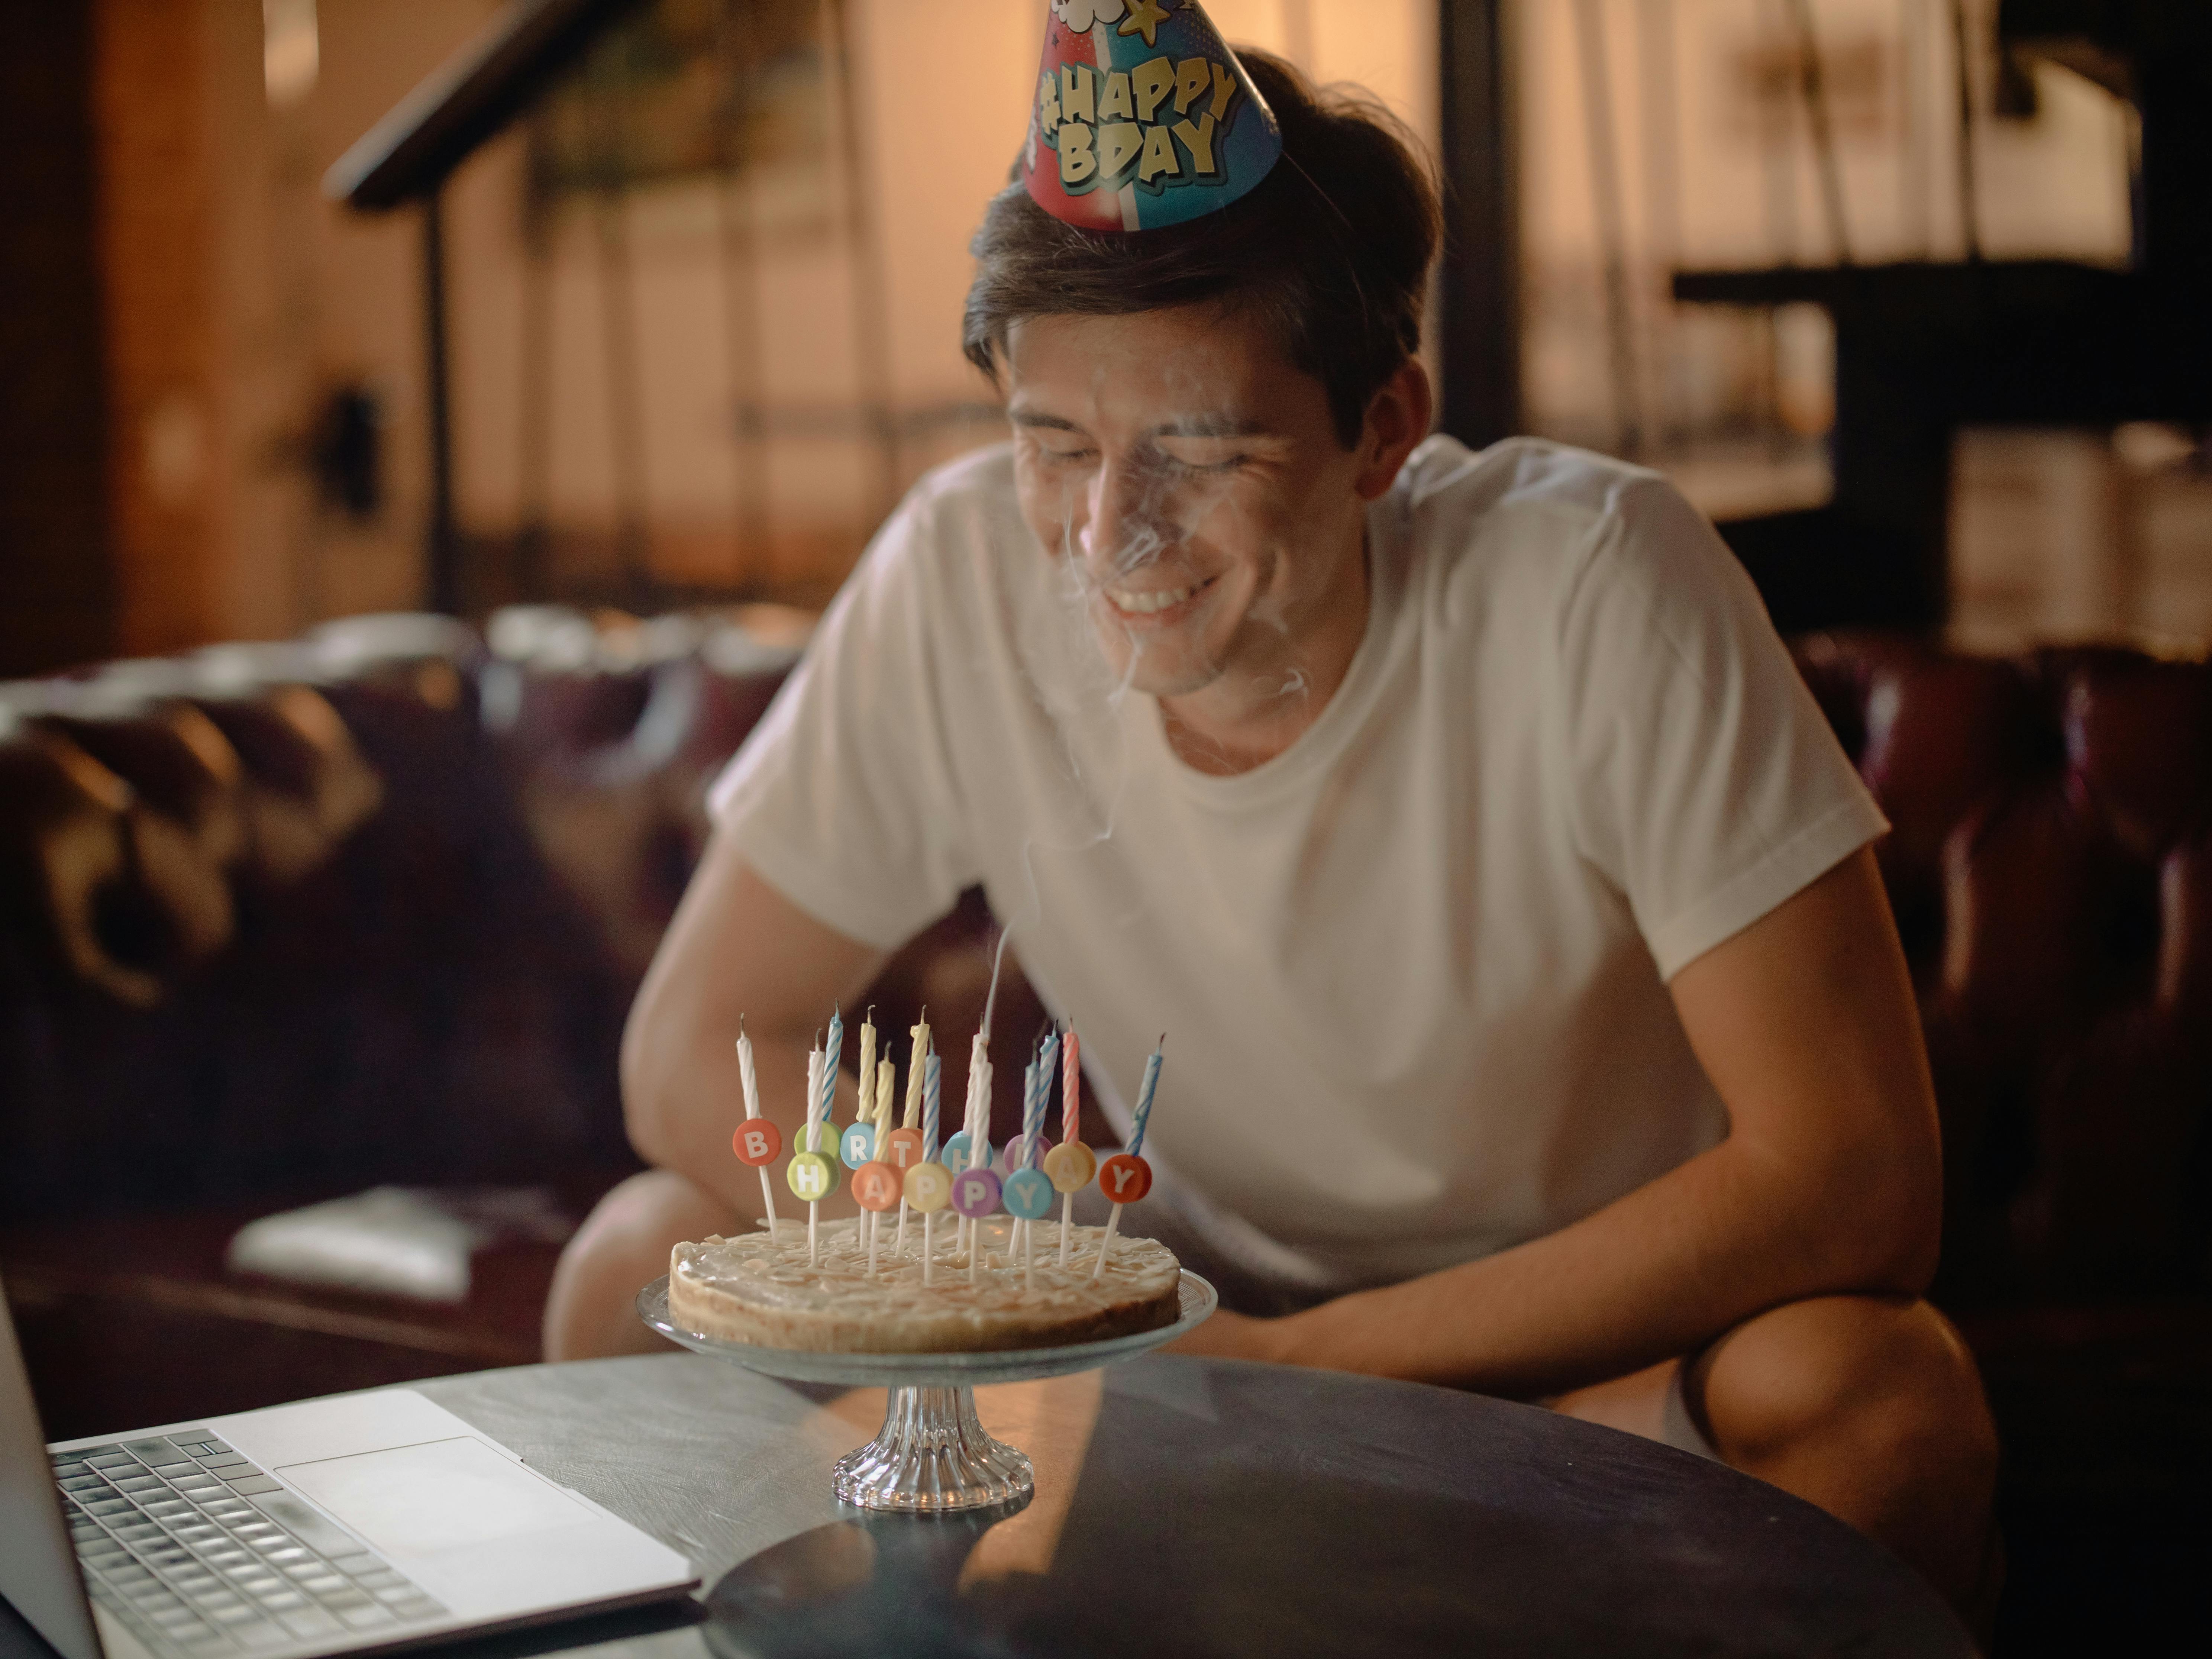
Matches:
[708,498,975,951]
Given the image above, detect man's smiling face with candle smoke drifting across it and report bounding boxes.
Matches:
[1004,307,1365,697]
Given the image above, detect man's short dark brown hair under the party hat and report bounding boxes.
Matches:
[960,46,1442,449]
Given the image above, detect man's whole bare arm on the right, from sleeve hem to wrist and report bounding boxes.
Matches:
[1183,849,1942,1398]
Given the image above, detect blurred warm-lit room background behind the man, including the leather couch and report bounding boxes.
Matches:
[0,0,2212,1652]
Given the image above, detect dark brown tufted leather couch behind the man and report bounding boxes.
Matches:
[0,610,2212,1650]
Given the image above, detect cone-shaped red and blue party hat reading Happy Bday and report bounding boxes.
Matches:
[1015,0,1283,230]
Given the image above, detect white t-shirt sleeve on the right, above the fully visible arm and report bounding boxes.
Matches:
[1559,478,1889,980]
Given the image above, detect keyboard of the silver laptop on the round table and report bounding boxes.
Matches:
[51,1429,445,1659]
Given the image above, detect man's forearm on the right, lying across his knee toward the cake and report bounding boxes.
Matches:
[1252,1142,1924,1398]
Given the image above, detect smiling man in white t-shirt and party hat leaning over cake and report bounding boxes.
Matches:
[549,0,1995,1608]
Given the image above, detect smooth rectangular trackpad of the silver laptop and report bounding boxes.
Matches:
[277,1436,595,1557]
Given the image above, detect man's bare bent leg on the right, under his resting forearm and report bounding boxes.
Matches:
[1551,1296,1998,1628]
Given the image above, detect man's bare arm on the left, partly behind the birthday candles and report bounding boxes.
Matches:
[621,834,902,1217]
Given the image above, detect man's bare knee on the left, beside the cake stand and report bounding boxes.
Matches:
[544,1170,745,1361]
